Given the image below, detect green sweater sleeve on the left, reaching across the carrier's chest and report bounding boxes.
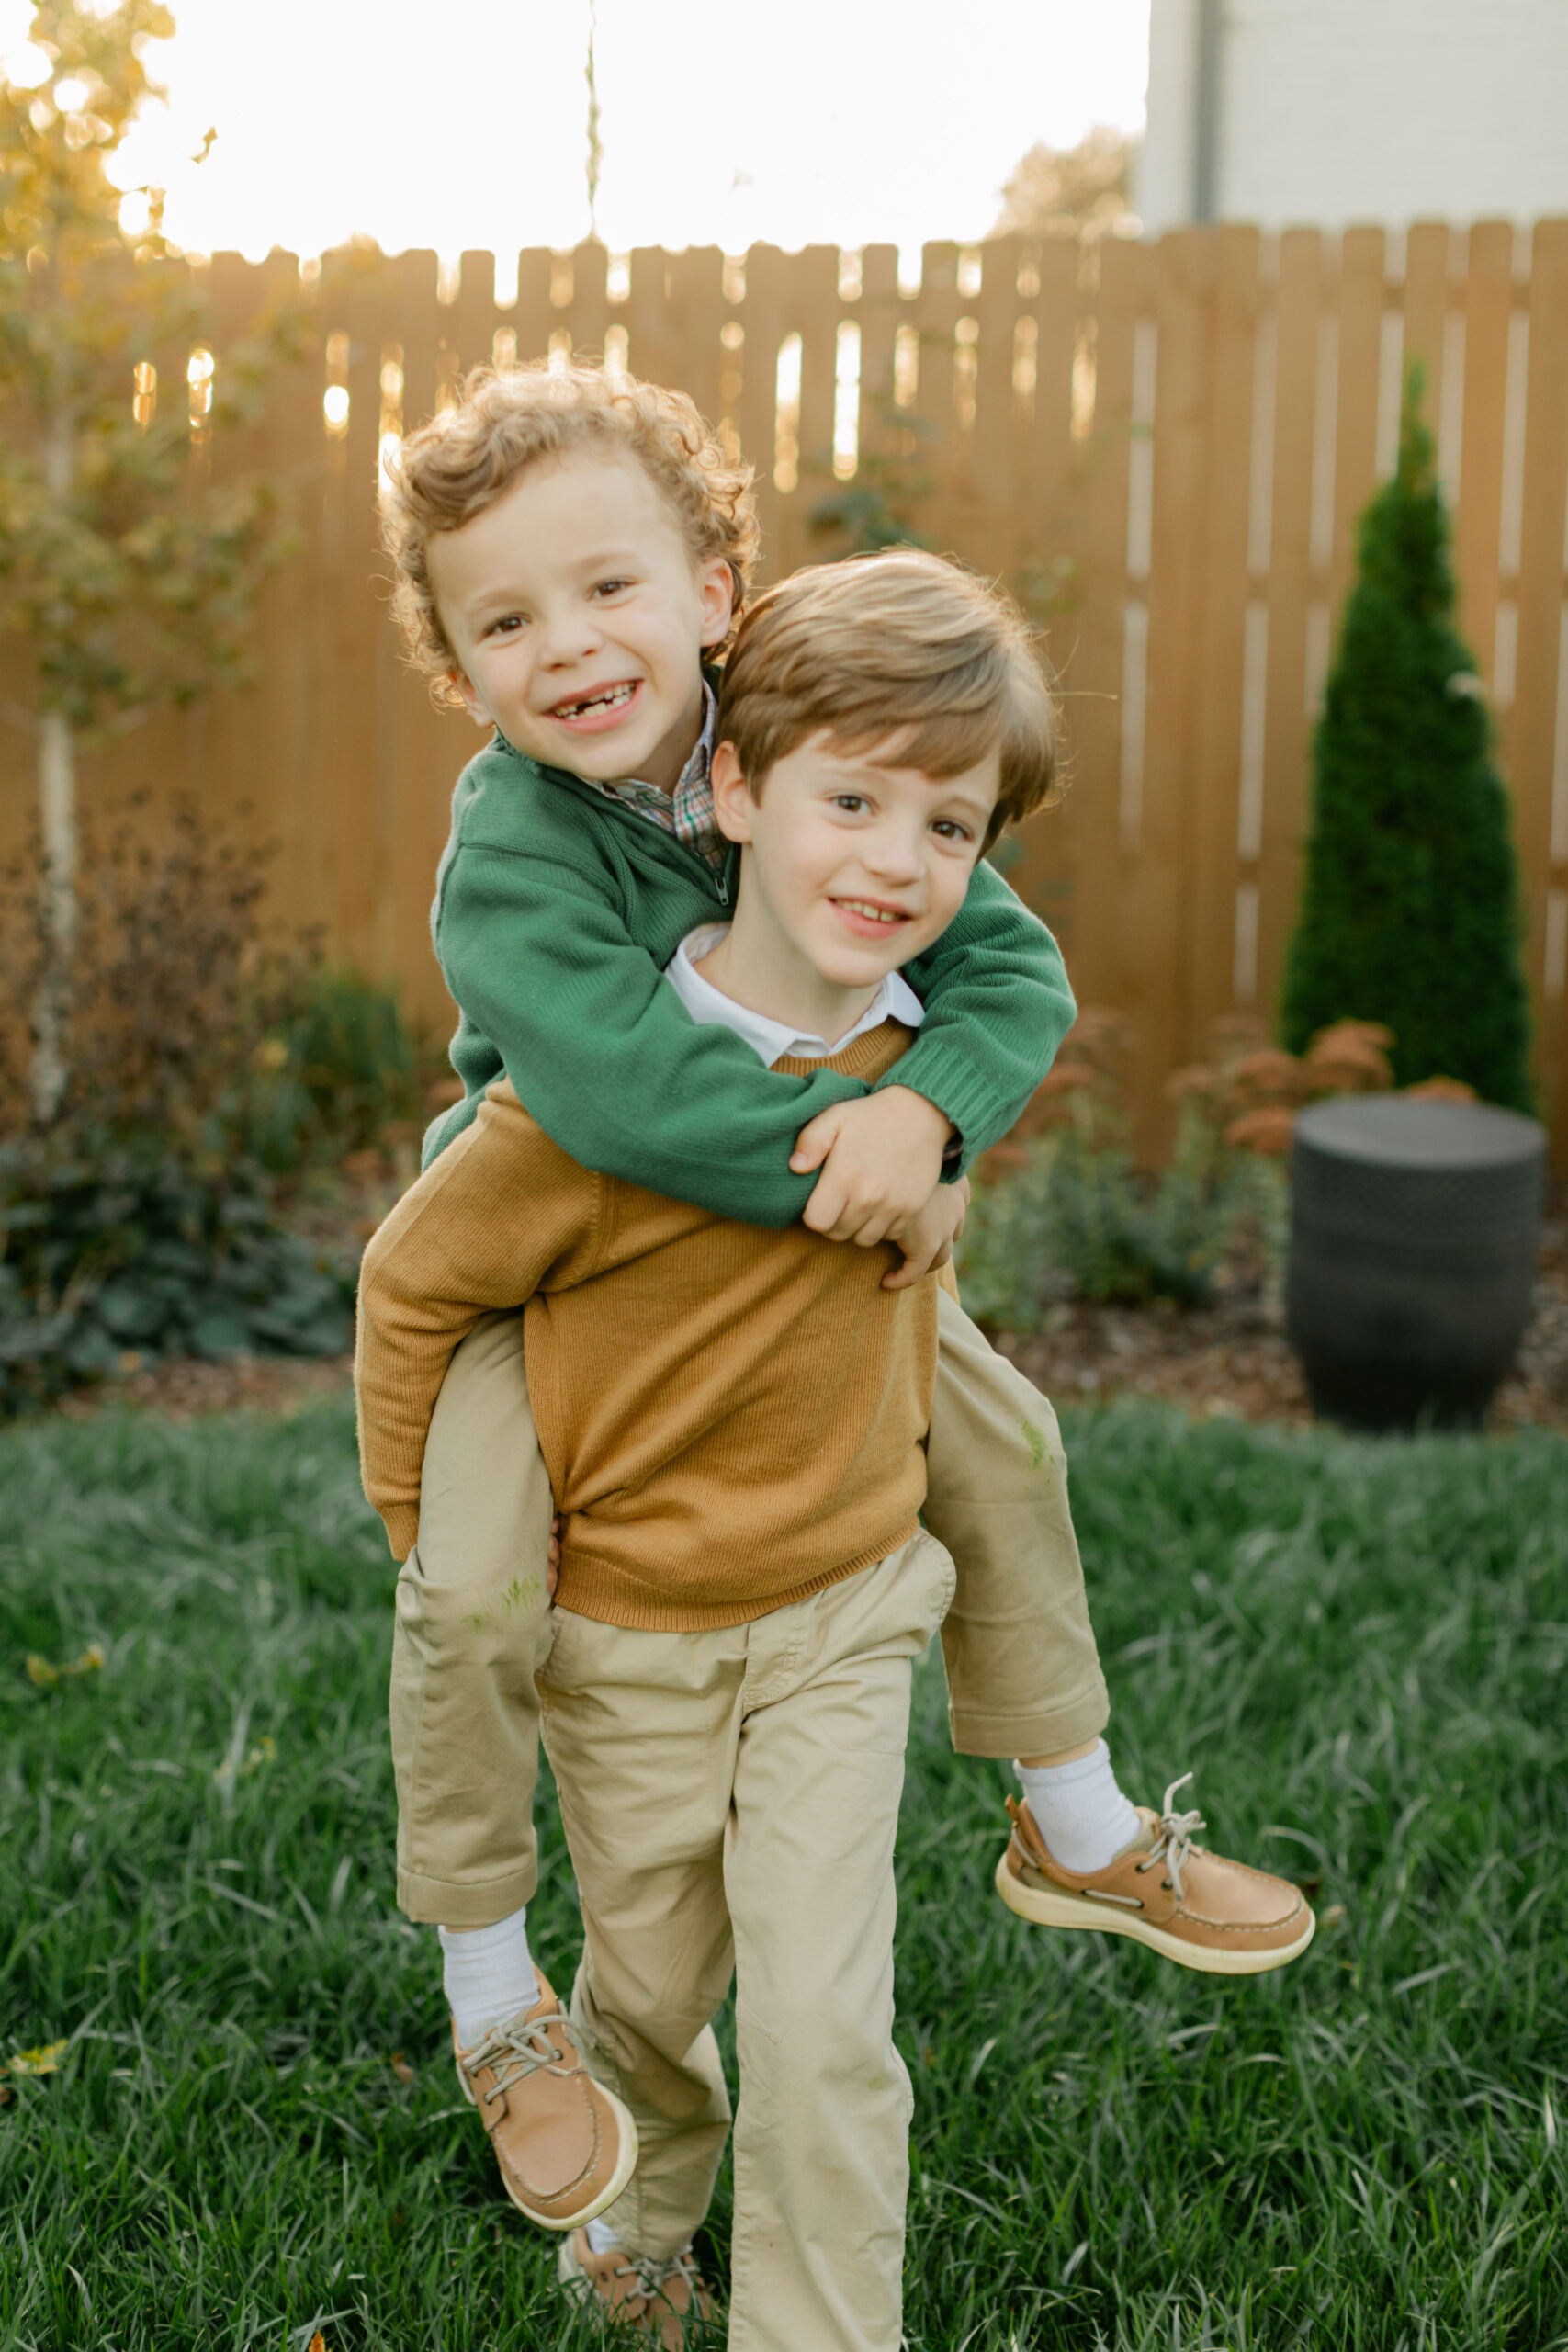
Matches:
[433,844,867,1226]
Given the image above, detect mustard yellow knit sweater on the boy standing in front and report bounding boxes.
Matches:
[355,1021,936,1630]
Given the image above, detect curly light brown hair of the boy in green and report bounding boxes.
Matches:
[381,360,757,706]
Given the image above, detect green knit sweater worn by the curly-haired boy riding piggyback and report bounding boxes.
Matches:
[425,736,1075,1226]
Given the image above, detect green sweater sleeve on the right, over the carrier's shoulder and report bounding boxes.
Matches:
[877,861,1077,1176]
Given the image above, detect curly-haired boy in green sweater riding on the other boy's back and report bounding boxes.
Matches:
[362,369,1312,2277]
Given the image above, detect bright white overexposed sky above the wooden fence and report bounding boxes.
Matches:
[101,0,1149,266]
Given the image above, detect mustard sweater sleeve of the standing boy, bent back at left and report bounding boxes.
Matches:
[355,1082,604,1559]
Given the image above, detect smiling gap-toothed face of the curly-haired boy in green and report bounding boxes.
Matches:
[430,452,733,793]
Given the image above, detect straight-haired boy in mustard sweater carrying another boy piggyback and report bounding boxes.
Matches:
[360,555,1054,2352]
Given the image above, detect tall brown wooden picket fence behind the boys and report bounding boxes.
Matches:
[5,221,1568,1150]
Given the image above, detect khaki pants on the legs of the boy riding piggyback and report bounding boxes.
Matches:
[392,1291,1110,1928]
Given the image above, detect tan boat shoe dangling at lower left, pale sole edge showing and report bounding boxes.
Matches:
[451,1973,637,2230]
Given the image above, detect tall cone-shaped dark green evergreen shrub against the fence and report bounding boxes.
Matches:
[1281,371,1530,1110]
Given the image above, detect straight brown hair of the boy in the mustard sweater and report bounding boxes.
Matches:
[719,548,1058,849]
